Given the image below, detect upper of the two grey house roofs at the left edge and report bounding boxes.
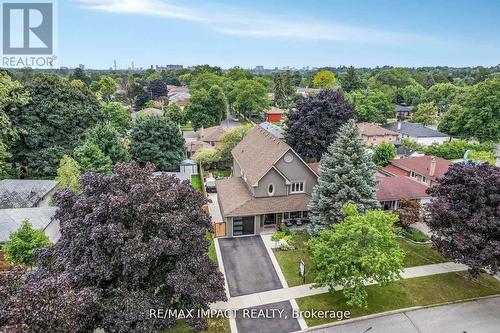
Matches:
[0,179,56,209]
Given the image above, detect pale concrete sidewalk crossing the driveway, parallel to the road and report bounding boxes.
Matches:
[211,262,467,310]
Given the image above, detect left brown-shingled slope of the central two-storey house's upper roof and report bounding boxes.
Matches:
[231,126,291,186]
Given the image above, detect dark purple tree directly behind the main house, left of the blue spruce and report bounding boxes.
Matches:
[285,90,354,161]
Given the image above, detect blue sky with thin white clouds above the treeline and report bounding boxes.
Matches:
[57,0,500,69]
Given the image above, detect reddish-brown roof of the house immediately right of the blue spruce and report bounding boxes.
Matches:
[376,175,430,201]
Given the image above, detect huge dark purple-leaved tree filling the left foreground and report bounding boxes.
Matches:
[0,163,226,333]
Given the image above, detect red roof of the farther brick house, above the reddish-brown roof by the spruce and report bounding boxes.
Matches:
[384,155,453,179]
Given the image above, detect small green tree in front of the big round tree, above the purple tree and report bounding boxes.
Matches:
[74,140,113,175]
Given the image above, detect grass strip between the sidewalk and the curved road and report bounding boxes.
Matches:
[297,272,500,326]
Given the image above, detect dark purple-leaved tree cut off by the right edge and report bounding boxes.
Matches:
[427,163,500,276]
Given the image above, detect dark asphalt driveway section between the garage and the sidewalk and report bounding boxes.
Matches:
[219,236,282,297]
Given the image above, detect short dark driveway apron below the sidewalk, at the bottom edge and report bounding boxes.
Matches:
[236,301,300,333]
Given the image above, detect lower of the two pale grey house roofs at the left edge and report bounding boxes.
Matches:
[0,207,60,244]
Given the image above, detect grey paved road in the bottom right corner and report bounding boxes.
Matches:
[311,297,500,333]
